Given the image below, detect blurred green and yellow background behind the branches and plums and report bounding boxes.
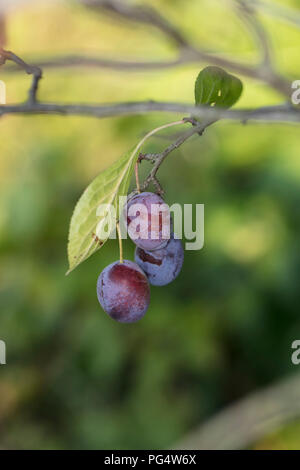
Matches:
[0,0,300,449]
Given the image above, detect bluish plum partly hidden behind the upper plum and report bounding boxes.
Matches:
[135,236,184,286]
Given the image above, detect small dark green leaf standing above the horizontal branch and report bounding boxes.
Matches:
[195,66,243,108]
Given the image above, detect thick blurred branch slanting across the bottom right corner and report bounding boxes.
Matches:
[175,374,300,450]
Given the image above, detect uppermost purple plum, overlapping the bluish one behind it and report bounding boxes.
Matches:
[125,192,171,251]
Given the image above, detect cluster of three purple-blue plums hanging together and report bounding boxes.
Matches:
[97,192,184,323]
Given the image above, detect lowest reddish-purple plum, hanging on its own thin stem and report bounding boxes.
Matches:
[97,260,150,323]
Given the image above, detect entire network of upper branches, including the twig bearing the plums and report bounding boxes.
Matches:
[0,0,300,192]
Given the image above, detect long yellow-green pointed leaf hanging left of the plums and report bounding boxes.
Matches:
[67,151,137,274]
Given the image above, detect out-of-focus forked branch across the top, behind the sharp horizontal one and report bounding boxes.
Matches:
[1,0,291,97]
